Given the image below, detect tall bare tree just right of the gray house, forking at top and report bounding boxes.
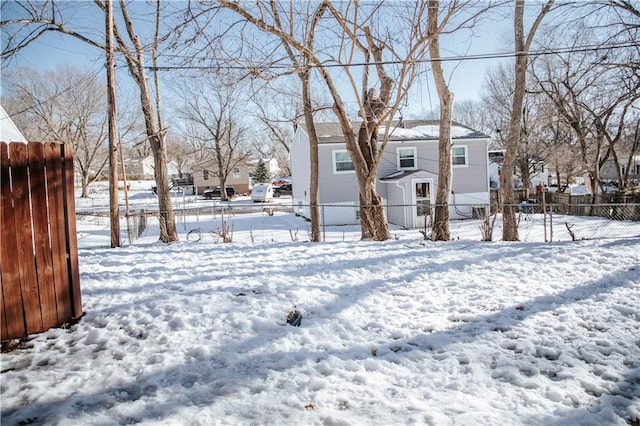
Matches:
[500,0,554,241]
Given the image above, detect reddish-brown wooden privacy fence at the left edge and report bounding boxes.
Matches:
[0,142,82,341]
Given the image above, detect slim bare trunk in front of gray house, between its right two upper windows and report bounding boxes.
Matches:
[427,0,454,241]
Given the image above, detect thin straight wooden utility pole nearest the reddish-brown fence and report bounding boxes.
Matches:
[105,0,120,248]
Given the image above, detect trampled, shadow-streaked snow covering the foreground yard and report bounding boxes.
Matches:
[0,185,640,425]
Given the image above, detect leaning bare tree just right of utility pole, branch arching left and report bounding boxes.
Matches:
[0,0,178,243]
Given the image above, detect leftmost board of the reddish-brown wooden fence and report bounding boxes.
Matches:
[0,143,27,340]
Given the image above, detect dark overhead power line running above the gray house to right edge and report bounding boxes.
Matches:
[146,43,640,71]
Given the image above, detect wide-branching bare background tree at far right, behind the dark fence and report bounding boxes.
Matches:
[533,26,640,194]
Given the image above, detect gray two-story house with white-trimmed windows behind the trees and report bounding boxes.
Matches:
[291,120,490,228]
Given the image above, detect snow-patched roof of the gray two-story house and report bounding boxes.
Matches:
[302,120,489,144]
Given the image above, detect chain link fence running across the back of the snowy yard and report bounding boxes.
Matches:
[77,200,640,248]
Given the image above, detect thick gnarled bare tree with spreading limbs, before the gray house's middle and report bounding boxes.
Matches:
[212,0,448,240]
